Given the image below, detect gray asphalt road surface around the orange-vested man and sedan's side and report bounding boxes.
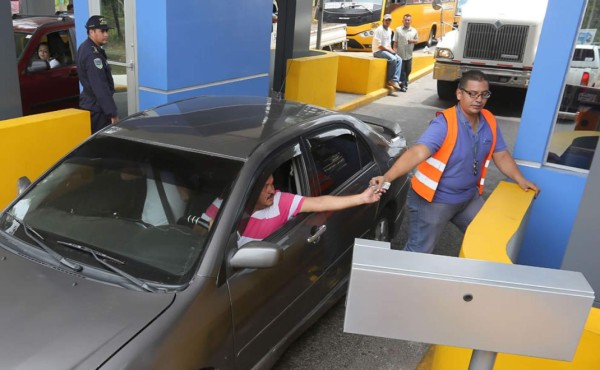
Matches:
[274,75,525,370]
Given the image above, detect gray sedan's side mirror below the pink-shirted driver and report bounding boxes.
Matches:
[229,241,283,269]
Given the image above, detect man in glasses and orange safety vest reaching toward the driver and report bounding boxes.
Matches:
[371,71,539,253]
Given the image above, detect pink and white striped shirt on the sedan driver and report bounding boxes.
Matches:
[202,190,304,247]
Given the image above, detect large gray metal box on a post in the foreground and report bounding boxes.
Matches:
[344,239,594,361]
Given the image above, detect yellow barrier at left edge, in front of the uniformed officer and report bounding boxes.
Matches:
[0,109,91,208]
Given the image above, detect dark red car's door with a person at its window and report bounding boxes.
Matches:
[19,29,79,115]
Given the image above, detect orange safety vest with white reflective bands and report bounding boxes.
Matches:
[411,106,496,202]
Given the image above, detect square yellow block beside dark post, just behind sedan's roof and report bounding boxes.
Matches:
[285,52,338,109]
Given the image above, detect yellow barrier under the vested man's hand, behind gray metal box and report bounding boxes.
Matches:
[418,182,600,370]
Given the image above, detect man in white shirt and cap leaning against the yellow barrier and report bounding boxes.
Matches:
[373,14,402,90]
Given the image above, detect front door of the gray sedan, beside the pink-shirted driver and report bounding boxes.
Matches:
[227,142,342,368]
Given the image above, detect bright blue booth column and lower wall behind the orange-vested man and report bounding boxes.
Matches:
[514,0,587,268]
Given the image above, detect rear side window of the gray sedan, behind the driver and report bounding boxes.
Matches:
[308,128,373,195]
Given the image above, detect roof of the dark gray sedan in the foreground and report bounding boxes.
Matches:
[99,96,333,160]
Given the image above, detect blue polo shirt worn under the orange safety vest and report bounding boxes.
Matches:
[417,105,507,204]
